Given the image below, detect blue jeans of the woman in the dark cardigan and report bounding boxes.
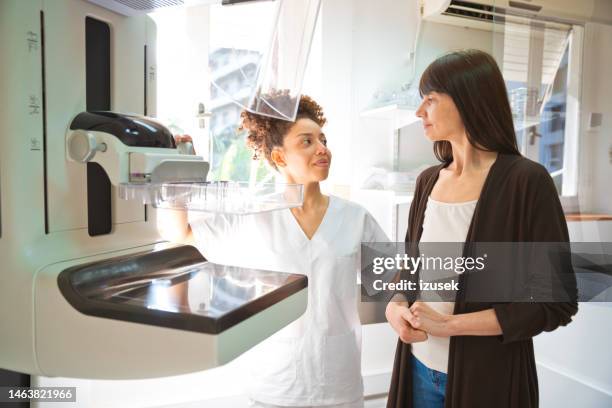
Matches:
[411,356,446,408]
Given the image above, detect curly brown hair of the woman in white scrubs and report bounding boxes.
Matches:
[238,90,327,169]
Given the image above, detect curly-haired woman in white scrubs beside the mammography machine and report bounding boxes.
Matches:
[161,92,387,407]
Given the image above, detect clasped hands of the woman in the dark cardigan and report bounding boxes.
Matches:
[385,301,453,343]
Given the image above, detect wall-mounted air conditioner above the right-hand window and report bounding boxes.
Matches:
[421,0,612,31]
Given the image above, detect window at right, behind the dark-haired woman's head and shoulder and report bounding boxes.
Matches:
[500,20,582,196]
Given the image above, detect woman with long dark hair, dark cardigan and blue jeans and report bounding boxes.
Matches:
[386,50,577,408]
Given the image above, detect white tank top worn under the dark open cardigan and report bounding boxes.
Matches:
[412,197,478,373]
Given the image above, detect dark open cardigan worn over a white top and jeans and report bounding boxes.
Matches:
[387,154,578,408]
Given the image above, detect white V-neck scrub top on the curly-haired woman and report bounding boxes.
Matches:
[189,196,388,406]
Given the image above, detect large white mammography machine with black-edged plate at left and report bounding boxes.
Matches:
[0,0,320,379]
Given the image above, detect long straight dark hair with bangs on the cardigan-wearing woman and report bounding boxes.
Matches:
[419,50,520,163]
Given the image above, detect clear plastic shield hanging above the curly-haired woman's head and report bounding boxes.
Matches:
[211,0,321,121]
